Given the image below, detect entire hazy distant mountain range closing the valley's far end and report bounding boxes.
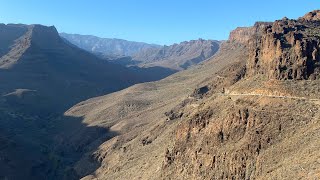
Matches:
[60,33,220,70]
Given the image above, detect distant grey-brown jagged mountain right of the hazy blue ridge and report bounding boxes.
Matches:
[132,39,220,70]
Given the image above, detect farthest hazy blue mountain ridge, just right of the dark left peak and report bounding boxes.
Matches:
[60,33,160,59]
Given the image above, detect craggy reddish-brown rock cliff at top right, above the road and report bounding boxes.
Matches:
[247,11,320,80]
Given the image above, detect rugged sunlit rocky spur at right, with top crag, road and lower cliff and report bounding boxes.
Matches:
[161,11,320,179]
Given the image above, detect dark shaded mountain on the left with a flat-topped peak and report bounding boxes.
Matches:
[0,24,168,179]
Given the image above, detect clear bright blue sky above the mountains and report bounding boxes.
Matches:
[0,0,320,45]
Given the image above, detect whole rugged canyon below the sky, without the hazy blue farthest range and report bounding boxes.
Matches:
[0,10,320,180]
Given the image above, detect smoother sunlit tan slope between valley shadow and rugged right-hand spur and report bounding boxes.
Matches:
[66,43,244,179]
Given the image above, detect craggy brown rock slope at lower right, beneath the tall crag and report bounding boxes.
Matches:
[162,79,320,180]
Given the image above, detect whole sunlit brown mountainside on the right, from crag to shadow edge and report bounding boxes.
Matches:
[65,10,320,179]
